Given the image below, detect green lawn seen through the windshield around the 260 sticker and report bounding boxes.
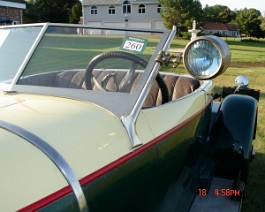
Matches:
[24,34,159,74]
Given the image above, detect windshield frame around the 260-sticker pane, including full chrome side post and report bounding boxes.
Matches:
[1,23,176,148]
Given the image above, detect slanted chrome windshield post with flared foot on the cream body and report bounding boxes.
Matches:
[121,27,176,148]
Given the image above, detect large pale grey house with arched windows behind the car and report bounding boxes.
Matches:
[82,0,165,33]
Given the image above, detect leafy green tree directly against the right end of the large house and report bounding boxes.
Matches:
[159,0,202,31]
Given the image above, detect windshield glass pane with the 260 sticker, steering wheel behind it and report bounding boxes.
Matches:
[18,26,162,93]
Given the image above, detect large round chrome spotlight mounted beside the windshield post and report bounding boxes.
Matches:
[183,36,231,80]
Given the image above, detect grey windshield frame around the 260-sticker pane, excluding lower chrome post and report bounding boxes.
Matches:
[1,23,173,117]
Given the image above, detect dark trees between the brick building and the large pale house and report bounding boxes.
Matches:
[25,0,82,23]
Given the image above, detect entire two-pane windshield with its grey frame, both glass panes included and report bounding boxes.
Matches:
[0,23,171,116]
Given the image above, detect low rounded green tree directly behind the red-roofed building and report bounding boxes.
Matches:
[203,5,236,23]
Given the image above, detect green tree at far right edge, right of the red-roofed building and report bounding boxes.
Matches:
[236,8,264,38]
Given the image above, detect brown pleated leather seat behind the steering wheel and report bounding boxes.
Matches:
[19,70,200,107]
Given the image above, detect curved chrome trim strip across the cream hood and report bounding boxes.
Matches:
[0,120,88,212]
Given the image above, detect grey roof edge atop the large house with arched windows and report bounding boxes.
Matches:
[83,0,158,5]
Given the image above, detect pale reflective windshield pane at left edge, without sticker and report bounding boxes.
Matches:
[0,27,41,83]
